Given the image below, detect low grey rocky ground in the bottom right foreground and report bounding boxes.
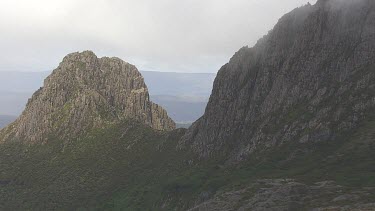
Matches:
[189,179,375,211]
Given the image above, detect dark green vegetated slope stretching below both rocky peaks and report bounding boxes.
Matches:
[0,118,375,210]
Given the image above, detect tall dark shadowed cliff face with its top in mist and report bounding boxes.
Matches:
[180,0,375,161]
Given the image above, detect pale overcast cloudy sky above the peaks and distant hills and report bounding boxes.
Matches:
[0,0,316,72]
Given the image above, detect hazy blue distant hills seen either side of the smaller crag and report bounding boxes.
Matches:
[0,71,215,122]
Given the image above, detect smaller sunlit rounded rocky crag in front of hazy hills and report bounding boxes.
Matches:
[0,51,175,143]
